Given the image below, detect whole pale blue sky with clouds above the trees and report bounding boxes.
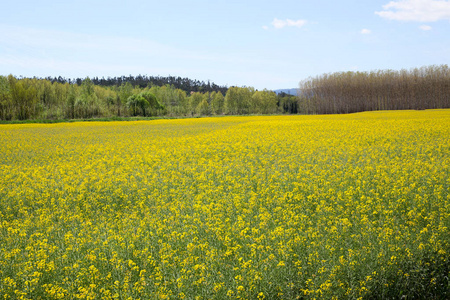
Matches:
[0,0,450,89]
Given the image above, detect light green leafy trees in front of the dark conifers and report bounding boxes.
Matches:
[0,75,297,120]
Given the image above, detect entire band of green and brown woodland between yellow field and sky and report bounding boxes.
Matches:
[0,65,450,120]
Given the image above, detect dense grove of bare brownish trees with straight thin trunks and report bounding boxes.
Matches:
[299,65,450,114]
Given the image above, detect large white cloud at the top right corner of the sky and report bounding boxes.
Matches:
[375,0,450,22]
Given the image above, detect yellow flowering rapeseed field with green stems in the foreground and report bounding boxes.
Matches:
[0,110,450,299]
